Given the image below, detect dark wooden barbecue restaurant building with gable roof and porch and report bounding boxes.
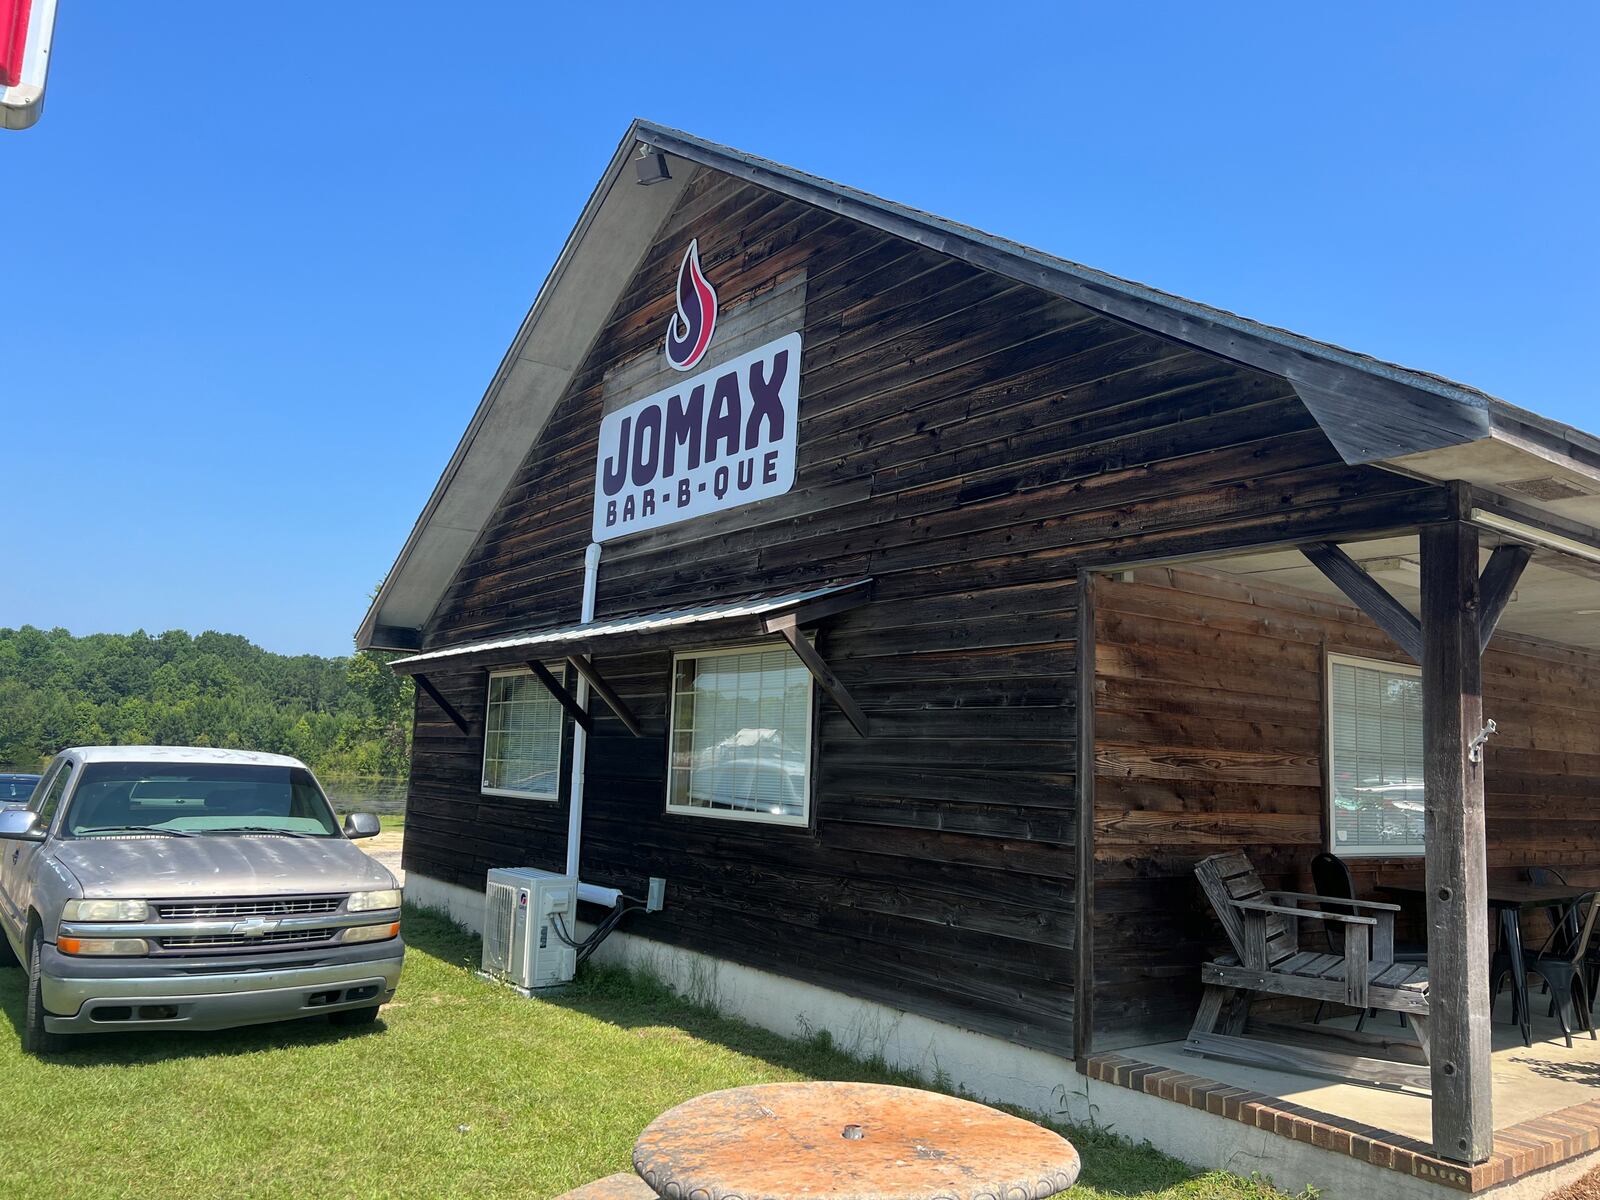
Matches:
[358,123,1600,1190]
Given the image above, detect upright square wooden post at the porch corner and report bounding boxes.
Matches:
[1421,520,1494,1163]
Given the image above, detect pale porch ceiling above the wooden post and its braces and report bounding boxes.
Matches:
[1203,530,1600,650]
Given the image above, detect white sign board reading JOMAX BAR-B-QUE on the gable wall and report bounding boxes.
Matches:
[594,331,800,542]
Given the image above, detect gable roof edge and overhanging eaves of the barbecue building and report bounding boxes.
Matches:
[357,120,1600,650]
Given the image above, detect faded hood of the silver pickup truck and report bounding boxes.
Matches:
[54,835,395,899]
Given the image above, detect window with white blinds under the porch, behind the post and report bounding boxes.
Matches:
[1328,654,1424,856]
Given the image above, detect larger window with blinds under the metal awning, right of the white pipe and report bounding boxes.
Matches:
[667,646,811,826]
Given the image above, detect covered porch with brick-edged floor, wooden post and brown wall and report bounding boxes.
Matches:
[1078,485,1600,1190]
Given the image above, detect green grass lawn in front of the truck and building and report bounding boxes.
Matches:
[0,910,1299,1200]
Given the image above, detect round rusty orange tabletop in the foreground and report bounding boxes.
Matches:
[634,1083,1078,1200]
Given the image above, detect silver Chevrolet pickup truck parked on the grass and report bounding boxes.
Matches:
[0,746,405,1053]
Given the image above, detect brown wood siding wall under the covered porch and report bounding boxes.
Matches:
[1093,568,1600,1050]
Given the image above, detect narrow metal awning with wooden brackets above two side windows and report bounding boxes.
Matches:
[390,579,872,736]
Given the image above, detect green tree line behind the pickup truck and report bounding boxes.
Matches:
[0,626,411,778]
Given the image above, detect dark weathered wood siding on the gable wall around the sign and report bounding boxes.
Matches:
[406,164,1442,1053]
